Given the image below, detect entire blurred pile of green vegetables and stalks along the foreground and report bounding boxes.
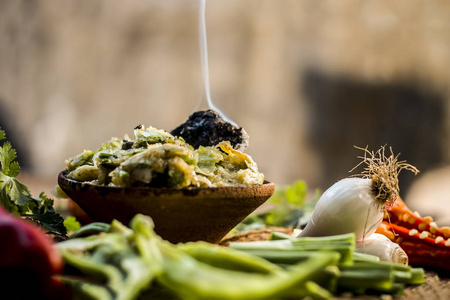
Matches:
[57,215,424,299]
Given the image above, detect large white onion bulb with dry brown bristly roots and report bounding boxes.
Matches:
[298,147,418,241]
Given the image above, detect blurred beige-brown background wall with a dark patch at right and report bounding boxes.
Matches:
[0,0,450,223]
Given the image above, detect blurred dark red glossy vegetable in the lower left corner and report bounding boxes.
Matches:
[0,206,66,299]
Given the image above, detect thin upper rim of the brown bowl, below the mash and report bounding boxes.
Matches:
[58,169,275,192]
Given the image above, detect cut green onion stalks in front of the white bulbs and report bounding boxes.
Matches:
[230,232,424,296]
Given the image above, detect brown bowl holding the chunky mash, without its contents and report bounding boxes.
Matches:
[58,171,275,243]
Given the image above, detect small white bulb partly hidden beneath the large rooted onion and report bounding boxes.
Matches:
[356,233,408,265]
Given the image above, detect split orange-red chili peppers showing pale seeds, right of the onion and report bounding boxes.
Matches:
[376,198,450,270]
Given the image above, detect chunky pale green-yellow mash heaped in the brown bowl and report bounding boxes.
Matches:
[65,125,264,188]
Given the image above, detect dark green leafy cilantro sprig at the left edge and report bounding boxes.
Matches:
[0,128,67,236]
